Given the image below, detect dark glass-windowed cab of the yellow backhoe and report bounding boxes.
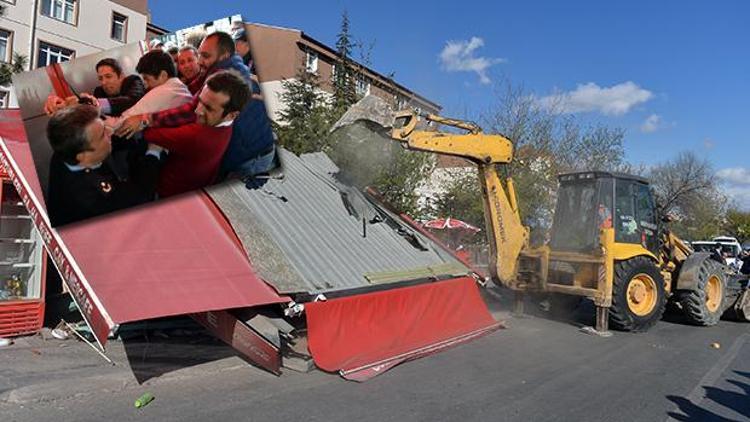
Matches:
[550,172,658,253]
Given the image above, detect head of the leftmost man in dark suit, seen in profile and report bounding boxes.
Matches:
[47,104,112,167]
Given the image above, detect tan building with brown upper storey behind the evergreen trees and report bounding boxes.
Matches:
[246,23,441,120]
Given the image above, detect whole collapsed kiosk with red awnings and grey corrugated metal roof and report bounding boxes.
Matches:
[0,107,500,380]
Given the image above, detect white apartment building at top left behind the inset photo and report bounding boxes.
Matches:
[0,0,149,107]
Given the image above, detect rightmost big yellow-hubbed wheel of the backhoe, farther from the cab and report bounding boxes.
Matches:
[678,259,727,327]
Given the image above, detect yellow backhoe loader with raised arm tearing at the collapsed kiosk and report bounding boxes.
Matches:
[343,97,750,333]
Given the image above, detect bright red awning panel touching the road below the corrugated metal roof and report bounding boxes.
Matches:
[305,277,501,381]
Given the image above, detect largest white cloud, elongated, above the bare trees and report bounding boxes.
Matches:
[538,81,654,116]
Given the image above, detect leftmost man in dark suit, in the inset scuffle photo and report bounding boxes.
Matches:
[47,104,160,226]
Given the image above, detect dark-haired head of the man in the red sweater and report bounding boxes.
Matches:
[195,70,251,126]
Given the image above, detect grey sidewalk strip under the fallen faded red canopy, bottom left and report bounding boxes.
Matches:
[0,326,274,406]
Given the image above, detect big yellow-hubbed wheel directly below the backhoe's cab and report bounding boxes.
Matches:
[609,256,667,332]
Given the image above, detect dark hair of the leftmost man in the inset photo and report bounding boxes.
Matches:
[47,104,99,165]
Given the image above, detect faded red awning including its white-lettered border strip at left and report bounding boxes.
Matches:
[0,111,288,346]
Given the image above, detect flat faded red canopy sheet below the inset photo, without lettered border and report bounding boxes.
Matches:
[58,191,285,323]
